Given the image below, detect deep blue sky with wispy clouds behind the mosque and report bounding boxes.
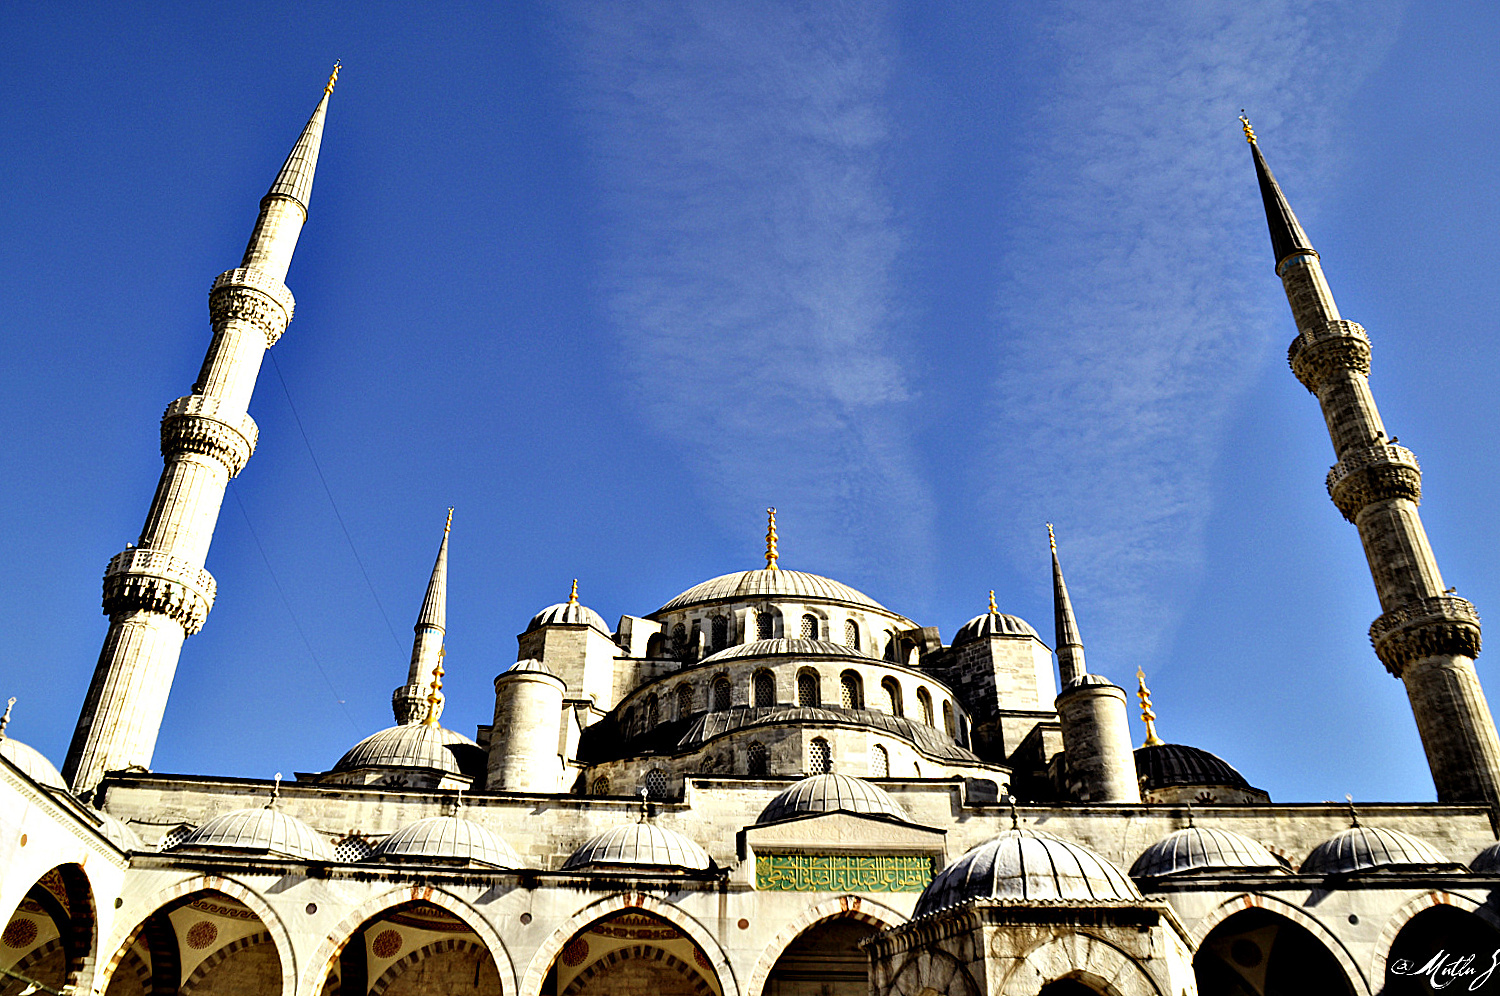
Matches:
[0,0,1500,801]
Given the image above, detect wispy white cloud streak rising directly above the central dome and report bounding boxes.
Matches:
[566,3,932,588]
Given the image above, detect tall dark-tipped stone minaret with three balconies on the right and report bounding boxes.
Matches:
[1241,116,1500,806]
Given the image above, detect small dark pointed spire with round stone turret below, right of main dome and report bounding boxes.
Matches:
[1047,522,1140,803]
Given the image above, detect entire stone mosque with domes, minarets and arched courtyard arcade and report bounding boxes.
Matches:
[0,72,1500,996]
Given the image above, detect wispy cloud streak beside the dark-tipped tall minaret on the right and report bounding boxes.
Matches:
[995,0,1400,657]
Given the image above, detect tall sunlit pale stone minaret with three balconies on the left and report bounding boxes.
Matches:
[63,65,339,792]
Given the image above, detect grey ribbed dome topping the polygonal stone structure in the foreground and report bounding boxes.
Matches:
[912,830,1142,917]
